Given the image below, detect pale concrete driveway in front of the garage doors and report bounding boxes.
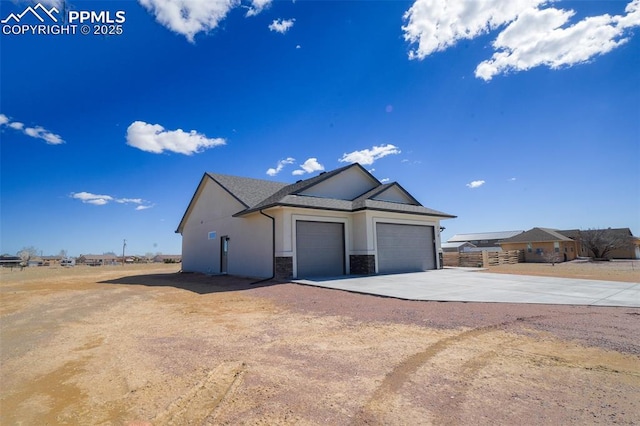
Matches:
[294,268,640,308]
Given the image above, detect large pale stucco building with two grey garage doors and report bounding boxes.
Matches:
[176,163,455,279]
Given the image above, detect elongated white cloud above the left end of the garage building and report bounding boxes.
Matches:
[127,121,226,155]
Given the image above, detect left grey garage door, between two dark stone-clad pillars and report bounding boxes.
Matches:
[296,221,345,278]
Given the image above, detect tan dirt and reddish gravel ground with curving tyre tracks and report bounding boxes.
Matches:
[0,265,640,425]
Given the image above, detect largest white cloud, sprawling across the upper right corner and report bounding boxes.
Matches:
[402,0,640,81]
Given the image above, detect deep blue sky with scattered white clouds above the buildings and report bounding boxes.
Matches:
[0,0,640,255]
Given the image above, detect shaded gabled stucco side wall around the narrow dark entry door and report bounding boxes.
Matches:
[182,180,273,277]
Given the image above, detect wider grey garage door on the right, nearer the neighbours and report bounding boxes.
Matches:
[376,223,436,274]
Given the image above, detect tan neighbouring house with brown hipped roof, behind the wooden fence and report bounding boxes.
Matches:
[500,228,578,263]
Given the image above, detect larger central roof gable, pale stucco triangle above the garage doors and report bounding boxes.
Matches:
[295,163,380,200]
